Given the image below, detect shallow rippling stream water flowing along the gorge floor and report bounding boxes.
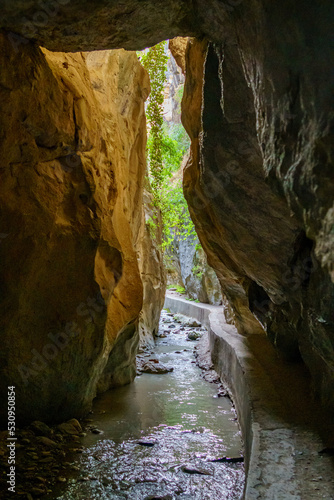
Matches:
[52,313,244,500]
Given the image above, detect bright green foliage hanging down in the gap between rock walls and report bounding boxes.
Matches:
[141,42,195,254]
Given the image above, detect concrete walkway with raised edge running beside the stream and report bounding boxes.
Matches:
[165,293,334,500]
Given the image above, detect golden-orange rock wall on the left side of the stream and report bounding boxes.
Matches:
[0,35,154,421]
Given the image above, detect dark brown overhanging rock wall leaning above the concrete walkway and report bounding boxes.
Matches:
[183,34,334,406]
